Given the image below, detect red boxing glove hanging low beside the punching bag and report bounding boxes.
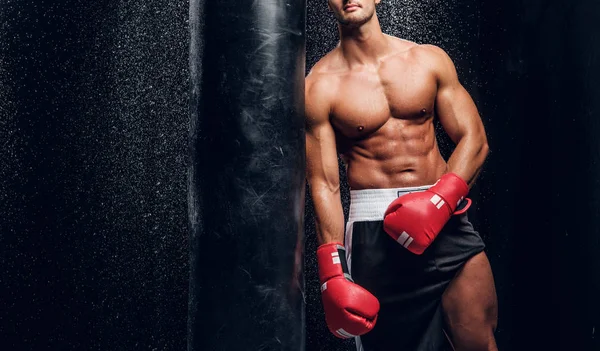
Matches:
[317,243,379,339]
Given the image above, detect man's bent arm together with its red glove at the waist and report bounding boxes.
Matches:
[383,46,488,255]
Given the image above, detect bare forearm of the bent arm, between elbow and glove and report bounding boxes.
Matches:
[448,137,489,188]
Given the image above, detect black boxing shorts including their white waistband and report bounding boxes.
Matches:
[345,186,485,351]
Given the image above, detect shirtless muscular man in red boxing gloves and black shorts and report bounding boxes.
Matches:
[305,0,497,351]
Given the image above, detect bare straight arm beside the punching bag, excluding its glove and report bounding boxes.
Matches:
[305,75,344,245]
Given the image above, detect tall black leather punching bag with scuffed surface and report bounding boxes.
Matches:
[188,0,305,351]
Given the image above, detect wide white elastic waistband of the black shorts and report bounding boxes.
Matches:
[348,185,431,222]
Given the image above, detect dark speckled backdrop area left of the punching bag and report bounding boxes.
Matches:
[0,0,189,350]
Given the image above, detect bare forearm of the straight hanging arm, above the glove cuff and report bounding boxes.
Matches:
[311,186,344,245]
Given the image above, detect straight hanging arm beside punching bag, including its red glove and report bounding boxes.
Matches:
[305,75,379,339]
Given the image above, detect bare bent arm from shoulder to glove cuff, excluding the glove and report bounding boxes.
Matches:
[427,46,489,187]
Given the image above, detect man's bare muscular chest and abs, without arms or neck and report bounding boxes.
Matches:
[327,38,446,190]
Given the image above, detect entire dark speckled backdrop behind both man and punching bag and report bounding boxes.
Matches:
[0,0,600,351]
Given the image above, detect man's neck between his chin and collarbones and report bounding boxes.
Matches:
[339,15,388,66]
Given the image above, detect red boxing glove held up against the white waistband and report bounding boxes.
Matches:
[383,173,471,255]
